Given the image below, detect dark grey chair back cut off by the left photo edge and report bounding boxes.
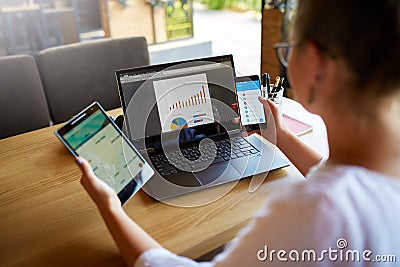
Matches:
[0,56,50,139]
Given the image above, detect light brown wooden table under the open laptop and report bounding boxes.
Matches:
[0,100,326,267]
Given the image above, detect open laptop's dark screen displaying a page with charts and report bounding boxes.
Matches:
[116,55,240,151]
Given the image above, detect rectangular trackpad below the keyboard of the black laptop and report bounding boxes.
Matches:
[193,163,241,185]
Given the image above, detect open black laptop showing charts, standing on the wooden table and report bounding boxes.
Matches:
[116,55,289,200]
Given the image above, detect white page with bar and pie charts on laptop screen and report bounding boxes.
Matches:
[153,73,214,132]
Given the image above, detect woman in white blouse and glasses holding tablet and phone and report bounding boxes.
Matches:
[77,0,400,266]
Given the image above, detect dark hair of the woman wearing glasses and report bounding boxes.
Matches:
[294,0,400,96]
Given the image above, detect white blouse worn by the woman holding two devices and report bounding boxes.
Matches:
[135,165,400,267]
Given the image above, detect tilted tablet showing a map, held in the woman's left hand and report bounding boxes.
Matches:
[55,102,154,204]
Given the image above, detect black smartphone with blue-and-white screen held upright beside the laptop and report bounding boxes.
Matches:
[235,75,267,131]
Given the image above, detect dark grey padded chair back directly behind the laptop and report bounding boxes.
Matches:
[36,37,149,123]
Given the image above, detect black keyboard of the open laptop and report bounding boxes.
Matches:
[150,137,259,176]
